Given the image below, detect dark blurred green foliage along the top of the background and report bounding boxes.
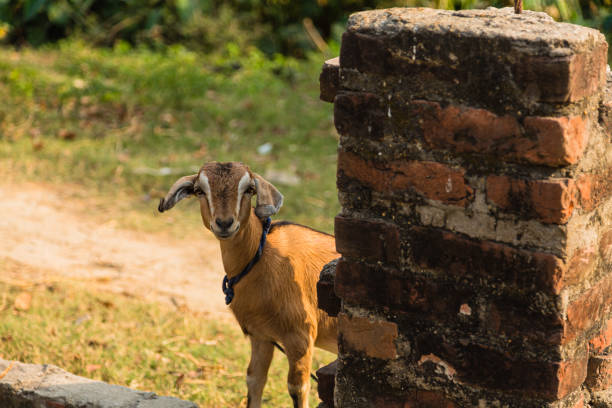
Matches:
[0,0,612,57]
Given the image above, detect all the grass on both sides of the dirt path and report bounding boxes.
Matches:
[0,41,339,407]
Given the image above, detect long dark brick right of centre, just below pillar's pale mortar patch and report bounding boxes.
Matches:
[408,227,565,294]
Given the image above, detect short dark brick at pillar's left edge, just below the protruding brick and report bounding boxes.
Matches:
[334,92,385,139]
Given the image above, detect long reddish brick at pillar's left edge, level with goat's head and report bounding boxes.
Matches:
[338,150,474,207]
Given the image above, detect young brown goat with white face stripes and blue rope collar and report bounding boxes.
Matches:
[158,162,339,408]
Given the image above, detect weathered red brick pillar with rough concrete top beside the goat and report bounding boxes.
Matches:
[321,8,612,408]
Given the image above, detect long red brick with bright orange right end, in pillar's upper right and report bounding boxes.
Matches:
[409,100,588,166]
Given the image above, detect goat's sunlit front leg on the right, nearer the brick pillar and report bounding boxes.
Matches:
[286,338,314,408]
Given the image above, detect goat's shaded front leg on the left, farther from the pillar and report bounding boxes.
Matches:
[247,336,274,408]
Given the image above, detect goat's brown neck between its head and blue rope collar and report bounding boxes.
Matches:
[219,210,263,278]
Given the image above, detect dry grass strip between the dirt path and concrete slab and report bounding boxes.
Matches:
[0,268,334,407]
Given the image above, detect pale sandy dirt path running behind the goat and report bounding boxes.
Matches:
[0,184,230,318]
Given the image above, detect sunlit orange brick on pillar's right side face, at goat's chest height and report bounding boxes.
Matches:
[563,276,612,343]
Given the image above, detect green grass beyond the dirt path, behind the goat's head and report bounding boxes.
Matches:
[0,41,339,236]
